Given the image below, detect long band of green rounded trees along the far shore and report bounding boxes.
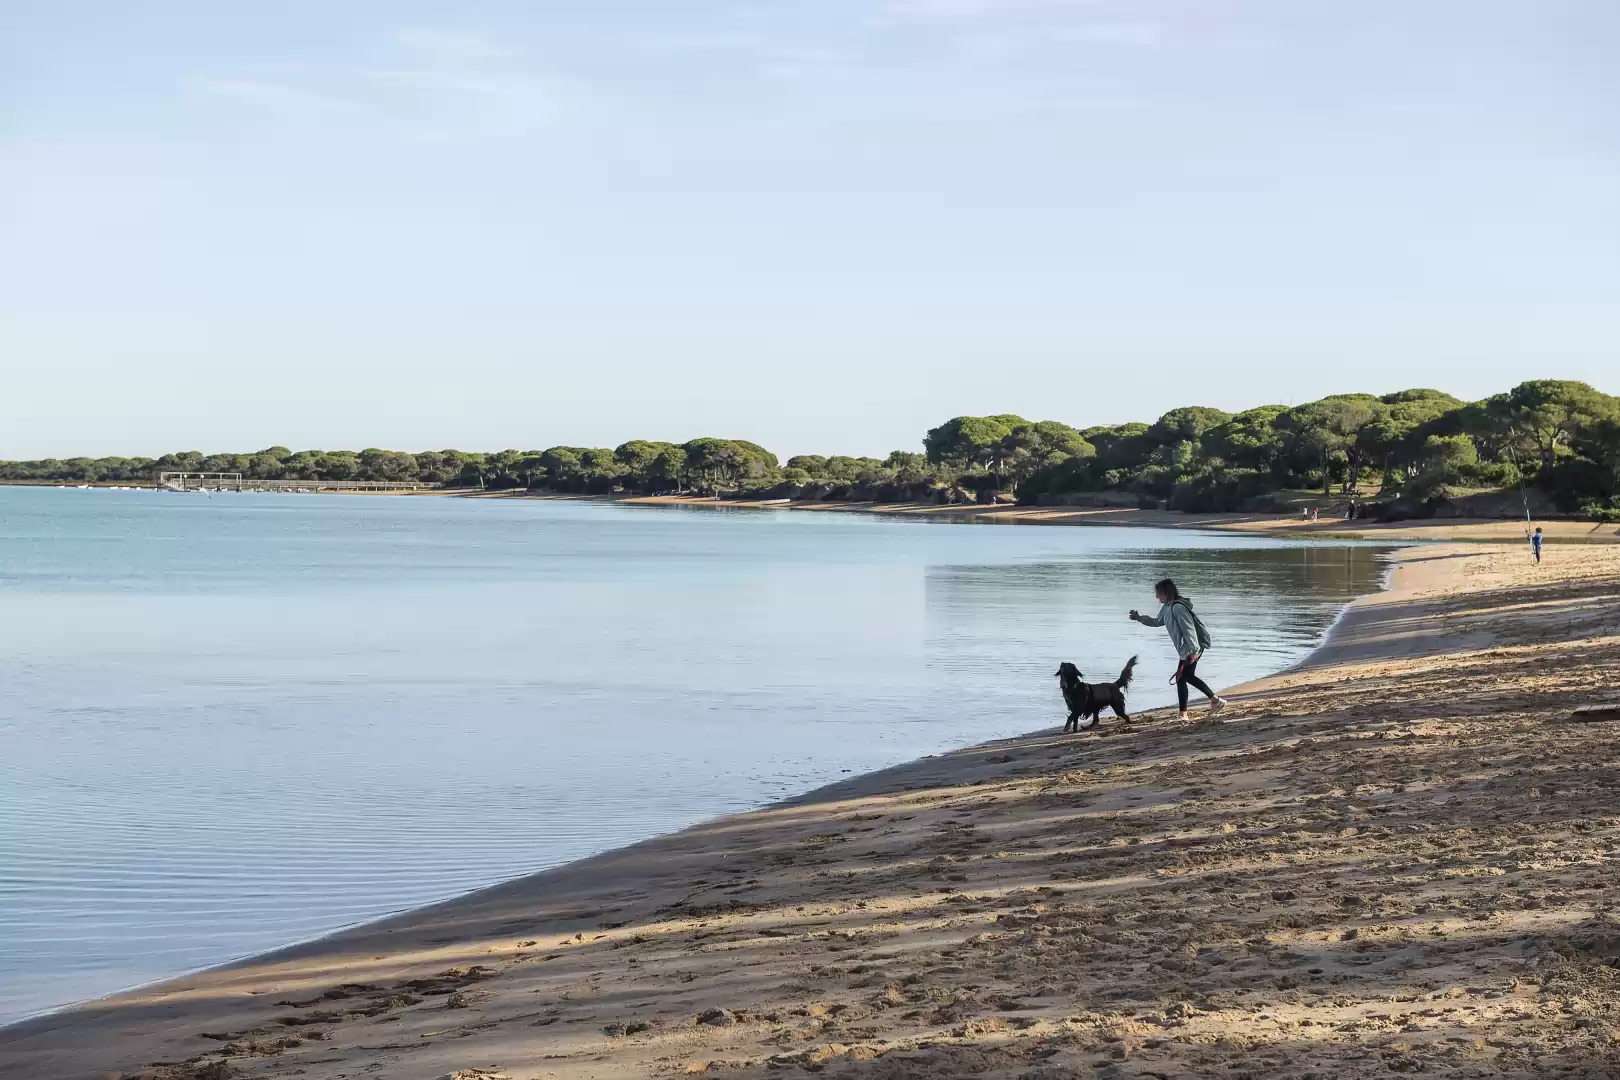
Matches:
[0,379,1620,517]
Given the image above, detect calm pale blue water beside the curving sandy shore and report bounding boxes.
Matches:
[0,487,1382,1022]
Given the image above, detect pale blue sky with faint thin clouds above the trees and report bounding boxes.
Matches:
[0,0,1620,458]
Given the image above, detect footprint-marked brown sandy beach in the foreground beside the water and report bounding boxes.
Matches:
[9,540,1620,1080]
